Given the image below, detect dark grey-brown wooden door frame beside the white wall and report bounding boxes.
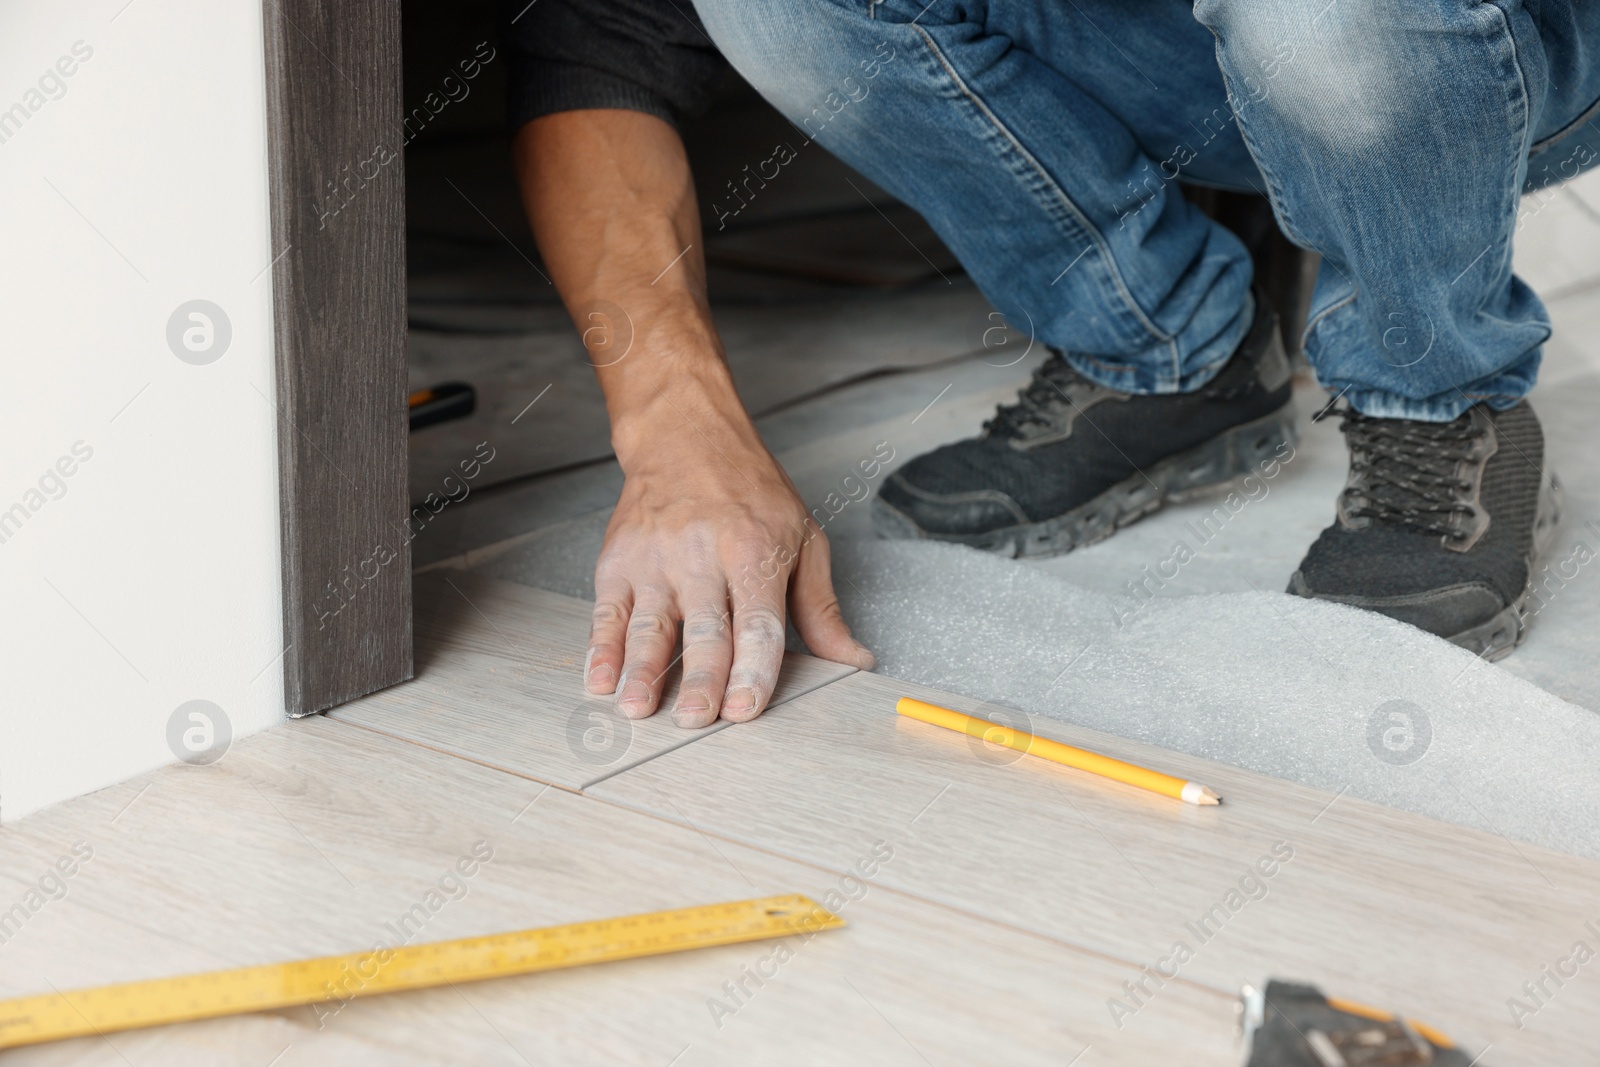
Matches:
[262,0,411,715]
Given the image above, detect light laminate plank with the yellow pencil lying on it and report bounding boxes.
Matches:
[590,673,1600,1065]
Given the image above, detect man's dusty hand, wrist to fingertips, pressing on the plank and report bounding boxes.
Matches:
[584,383,872,726]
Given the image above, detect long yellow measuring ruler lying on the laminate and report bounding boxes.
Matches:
[0,894,845,1048]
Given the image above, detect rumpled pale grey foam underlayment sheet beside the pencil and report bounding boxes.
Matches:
[834,541,1600,859]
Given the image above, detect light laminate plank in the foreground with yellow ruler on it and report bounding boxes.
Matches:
[0,717,1235,1067]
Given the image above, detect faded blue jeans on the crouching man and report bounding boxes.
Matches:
[696,0,1600,421]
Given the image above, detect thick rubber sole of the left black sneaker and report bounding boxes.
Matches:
[872,403,1299,558]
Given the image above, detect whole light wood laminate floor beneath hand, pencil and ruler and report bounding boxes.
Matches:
[0,574,1600,1067]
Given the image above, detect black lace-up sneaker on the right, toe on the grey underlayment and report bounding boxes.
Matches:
[1290,402,1560,659]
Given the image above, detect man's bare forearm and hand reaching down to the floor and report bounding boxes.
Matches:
[514,109,872,726]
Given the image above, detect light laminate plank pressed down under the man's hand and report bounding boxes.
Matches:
[330,571,854,790]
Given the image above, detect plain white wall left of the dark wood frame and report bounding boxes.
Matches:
[0,0,283,821]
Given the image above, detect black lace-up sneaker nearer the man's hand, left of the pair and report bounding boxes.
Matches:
[872,294,1296,555]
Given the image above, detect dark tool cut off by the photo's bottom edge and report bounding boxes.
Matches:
[1238,979,1482,1067]
